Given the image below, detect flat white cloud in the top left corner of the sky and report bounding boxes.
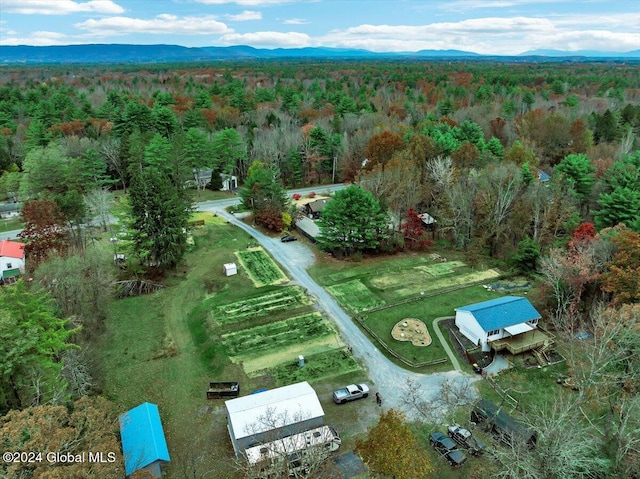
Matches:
[0,0,124,15]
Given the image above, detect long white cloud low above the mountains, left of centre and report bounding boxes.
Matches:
[74,13,233,36]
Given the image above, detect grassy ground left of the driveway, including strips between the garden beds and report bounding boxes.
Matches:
[95,213,377,479]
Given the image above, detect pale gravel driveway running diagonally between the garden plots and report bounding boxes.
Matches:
[212,207,474,417]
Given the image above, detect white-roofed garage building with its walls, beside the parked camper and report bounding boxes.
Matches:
[225,381,324,457]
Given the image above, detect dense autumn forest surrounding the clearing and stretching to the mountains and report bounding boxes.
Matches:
[0,61,640,477]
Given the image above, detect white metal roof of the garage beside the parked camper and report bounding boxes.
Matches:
[225,381,324,439]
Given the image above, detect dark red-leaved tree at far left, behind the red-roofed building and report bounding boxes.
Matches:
[18,200,68,267]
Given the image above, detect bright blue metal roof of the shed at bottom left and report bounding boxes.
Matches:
[120,402,170,476]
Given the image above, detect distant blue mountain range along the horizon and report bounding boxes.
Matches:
[0,44,640,65]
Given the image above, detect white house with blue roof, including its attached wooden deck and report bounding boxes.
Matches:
[455,296,552,354]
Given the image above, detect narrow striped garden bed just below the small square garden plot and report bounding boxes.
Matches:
[213,286,312,324]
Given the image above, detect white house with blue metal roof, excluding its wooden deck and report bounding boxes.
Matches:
[455,296,544,351]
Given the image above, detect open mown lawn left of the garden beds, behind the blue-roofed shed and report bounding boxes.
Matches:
[91,215,264,479]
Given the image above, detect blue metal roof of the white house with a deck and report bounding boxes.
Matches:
[455,296,540,332]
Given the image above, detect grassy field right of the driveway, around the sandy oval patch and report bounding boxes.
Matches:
[309,253,508,372]
